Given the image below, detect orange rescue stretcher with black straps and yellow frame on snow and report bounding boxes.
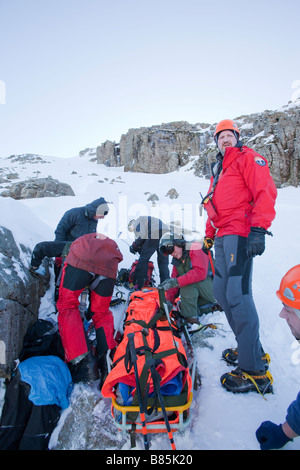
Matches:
[101,288,196,448]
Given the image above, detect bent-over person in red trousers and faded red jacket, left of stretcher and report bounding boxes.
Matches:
[56,233,123,388]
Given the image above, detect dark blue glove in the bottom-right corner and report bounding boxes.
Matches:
[255,421,293,450]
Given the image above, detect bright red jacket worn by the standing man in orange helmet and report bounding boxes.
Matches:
[204,146,277,238]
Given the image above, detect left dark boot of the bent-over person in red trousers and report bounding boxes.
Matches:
[68,351,99,383]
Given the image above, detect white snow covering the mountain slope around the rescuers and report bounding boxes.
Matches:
[0,151,300,450]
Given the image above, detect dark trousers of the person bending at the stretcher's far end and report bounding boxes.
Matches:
[134,239,170,289]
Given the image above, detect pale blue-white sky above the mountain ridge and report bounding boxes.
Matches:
[0,0,300,157]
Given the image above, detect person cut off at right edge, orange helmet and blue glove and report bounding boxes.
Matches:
[256,264,300,450]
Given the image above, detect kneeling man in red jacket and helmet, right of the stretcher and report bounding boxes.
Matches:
[159,233,216,322]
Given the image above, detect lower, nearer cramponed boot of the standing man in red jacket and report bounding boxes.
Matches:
[220,367,273,395]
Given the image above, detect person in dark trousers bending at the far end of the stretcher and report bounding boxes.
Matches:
[128,216,170,289]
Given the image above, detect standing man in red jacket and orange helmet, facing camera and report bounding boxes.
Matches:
[202,119,277,393]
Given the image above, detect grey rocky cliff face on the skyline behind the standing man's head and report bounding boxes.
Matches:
[97,99,300,187]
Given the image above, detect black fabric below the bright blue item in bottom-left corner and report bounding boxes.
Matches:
[0,370,60,450]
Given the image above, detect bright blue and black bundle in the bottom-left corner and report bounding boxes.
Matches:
[0,356,72,450]
